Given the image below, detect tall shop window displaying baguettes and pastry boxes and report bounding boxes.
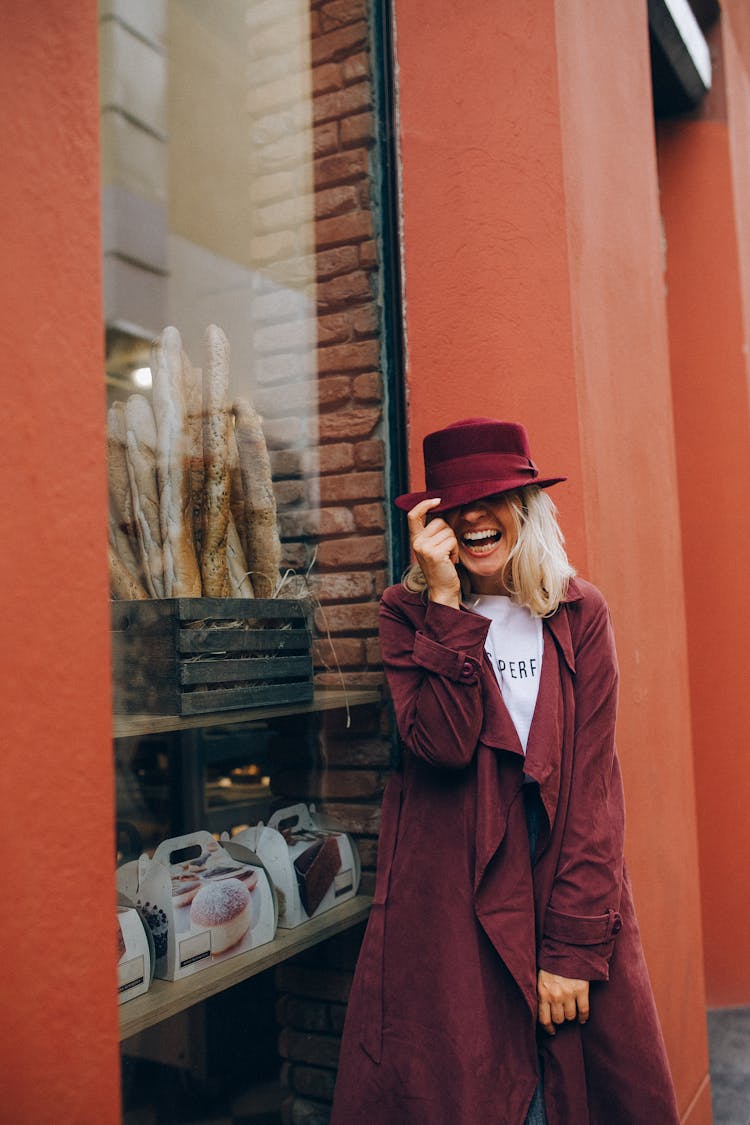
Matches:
[100,0,394,1122]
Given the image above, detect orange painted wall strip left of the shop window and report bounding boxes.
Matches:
[0,0,119,1125]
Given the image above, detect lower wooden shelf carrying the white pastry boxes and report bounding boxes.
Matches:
[119,894,372,1040]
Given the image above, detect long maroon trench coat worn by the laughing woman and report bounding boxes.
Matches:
[332,579,679,1125]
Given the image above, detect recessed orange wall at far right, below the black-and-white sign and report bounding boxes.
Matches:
[659,6,750,1006]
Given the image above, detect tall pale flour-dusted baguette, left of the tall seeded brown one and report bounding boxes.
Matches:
[151,327,201,597]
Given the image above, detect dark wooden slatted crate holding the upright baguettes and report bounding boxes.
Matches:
[111,597,313,716]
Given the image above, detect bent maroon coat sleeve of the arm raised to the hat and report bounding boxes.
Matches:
[380,591,489,770]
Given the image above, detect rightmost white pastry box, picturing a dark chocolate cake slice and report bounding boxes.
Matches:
[234,804,361,928]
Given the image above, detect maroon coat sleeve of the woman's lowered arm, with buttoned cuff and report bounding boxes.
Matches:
[539,595,624,980]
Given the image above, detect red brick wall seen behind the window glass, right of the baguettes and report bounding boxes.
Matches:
[253,0,392,1125]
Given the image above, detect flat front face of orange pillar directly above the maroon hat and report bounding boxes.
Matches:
[395,0,586,568]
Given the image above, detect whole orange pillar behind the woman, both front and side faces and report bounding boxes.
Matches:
[396,0,711,1123]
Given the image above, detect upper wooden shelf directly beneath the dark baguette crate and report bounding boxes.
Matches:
[112,689,381,738]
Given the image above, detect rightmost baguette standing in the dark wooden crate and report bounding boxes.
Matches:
[233,398,281,597]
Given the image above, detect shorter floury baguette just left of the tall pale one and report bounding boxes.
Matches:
[125,395,164,597]
